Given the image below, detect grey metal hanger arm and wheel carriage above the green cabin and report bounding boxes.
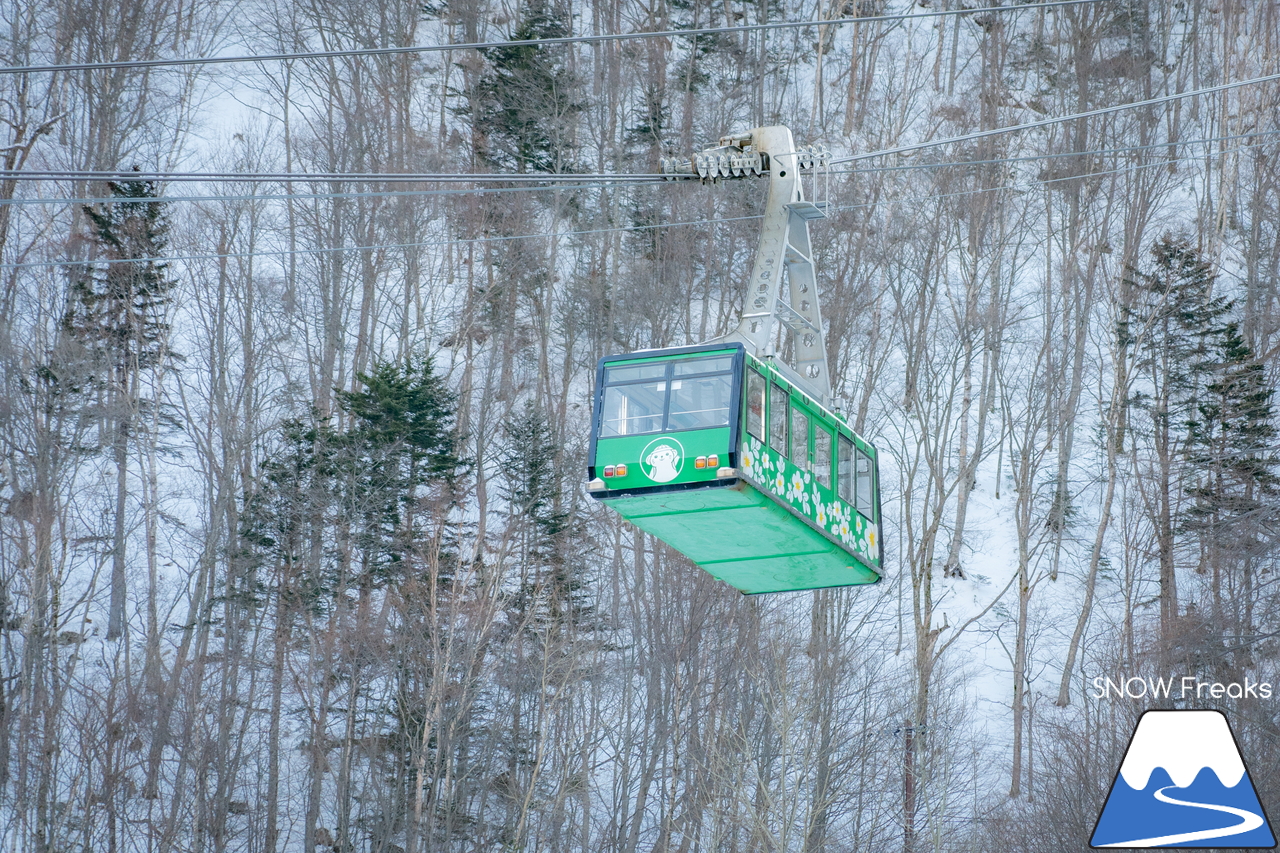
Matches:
[662,126,832,405]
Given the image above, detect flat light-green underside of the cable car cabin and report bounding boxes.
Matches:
[603,480,879,594]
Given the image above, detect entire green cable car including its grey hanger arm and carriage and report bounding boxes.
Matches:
[588,127,883,594]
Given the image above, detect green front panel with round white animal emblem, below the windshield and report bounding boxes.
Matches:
[595,427,730,491]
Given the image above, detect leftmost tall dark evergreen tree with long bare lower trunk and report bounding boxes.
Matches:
[63,167,174,639]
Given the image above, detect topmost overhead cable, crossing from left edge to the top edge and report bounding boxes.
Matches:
[0,0,1105,74]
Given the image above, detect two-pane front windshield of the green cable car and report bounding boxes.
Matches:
[600,355,733,437]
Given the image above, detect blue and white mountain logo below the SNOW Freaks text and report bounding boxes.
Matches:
[1089,711,1276,849]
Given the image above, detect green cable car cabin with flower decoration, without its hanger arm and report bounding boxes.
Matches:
[588,343,883,593]
